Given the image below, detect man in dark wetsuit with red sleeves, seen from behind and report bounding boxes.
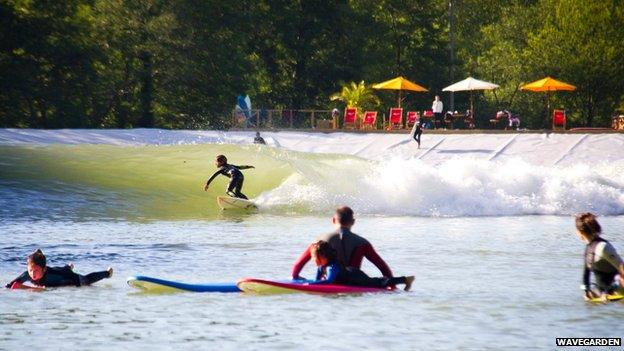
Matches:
[292,206,392,280]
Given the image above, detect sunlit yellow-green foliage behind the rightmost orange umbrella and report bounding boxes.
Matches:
[478,0,624,128]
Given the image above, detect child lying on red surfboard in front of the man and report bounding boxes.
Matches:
[308,240,414,291]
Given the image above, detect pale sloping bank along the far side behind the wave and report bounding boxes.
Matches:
[0,129,624,166]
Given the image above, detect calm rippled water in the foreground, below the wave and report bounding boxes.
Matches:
[0,215,624,350]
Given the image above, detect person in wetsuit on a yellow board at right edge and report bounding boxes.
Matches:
[575,212,624,301]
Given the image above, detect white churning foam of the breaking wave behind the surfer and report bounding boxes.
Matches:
[257,158,624,216]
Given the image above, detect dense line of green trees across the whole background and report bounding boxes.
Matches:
[0,0,624,128]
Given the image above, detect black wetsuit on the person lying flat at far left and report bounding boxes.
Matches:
[6,266,110,288]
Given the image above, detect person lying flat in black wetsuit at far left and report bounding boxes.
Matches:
[6,250,113,289]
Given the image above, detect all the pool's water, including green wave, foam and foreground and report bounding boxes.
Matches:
[0,145,624,350]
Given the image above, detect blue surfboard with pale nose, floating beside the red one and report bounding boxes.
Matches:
[126,275,241,293]
